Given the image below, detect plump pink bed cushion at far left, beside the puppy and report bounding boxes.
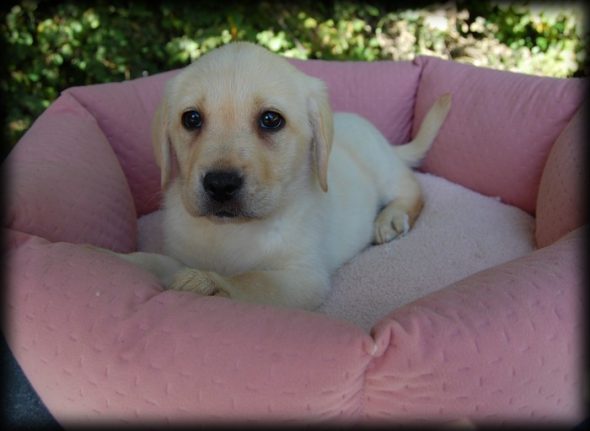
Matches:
[3,94,137,251]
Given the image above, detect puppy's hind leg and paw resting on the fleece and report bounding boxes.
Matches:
[373,170,423,244]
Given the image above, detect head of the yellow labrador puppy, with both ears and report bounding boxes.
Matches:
[153,43,333,221]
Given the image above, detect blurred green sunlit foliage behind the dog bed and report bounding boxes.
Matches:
[0,0,588,154]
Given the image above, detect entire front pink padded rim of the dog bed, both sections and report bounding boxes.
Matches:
[5,231,583,426]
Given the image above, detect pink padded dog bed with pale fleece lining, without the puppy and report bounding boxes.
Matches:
[4,57,585,427]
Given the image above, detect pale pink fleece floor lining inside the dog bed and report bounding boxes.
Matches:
[139,173,534,331]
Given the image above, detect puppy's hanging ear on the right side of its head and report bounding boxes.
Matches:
[307,79,334,192]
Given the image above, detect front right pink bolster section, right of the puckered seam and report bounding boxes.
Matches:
[364,230,584,427]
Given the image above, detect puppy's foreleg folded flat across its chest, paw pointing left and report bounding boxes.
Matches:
[171,268,329,310]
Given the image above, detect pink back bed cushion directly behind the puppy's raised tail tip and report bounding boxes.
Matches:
[413,57,585,214]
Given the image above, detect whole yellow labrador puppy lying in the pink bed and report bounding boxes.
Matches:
[111,43,451,309]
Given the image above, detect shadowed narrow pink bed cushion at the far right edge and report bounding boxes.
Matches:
[535,102,588,247]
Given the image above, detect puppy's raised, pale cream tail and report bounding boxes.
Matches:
[394,93,451,167]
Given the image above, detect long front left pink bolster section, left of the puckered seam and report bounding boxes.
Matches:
[7,232,373,426]
